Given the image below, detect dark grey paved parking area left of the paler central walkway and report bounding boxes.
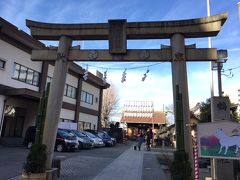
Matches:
[0,142,131,180]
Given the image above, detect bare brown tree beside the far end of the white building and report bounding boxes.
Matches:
[101,85,119,127]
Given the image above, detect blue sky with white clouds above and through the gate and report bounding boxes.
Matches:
[0,0,240,121]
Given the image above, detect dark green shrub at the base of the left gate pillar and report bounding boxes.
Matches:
[24,144,47,174]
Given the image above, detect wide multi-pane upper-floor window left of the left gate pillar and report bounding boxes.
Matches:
[12,63,40,86]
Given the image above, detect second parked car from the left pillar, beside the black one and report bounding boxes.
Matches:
[67,130,94,149]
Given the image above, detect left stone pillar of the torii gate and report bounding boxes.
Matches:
[43,36,72,169]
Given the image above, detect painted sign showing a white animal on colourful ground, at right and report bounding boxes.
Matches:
[197,121,240,159]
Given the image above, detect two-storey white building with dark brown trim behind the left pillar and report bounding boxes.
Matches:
[0,18,109,145]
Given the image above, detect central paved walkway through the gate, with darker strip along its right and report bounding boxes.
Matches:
[93,146,170,180]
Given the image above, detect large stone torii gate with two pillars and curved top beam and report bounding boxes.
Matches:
[26,13,228,169]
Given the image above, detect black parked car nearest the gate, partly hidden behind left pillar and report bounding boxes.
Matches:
[23,126,79,152]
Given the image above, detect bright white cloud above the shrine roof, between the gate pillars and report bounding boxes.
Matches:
[108,71,173,110]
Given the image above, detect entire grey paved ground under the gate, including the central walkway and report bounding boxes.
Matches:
[0,142,172,180]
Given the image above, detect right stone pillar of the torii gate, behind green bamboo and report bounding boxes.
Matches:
[171,34,194,169]
